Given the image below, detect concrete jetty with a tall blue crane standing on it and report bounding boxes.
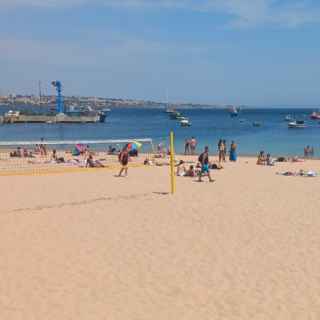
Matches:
[1,80,107,124]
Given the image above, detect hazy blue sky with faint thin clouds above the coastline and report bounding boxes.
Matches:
[0,0,320,106]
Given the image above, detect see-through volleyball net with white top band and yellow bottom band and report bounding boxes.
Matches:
[0,138,155,175]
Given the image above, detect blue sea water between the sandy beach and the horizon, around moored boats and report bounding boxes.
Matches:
[0,107,320,157]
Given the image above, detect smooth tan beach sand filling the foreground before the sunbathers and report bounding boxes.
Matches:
[0,158,320,320]
